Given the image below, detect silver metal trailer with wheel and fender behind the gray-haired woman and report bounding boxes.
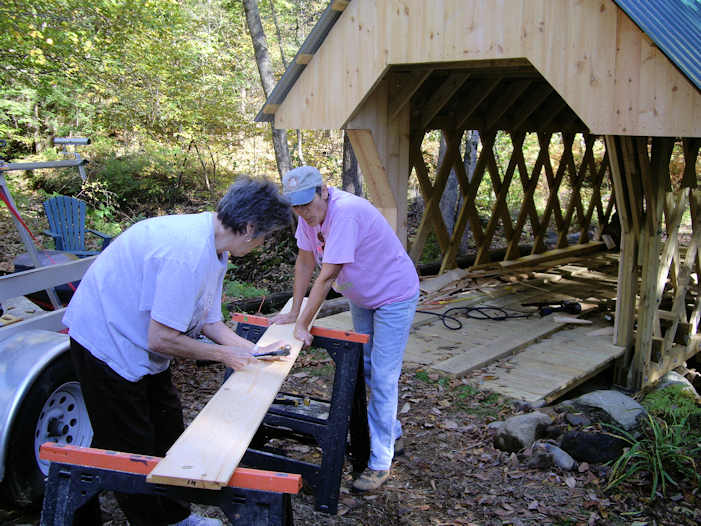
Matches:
[0,138,97,506]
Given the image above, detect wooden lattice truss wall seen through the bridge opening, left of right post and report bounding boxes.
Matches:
[409,130,615,271]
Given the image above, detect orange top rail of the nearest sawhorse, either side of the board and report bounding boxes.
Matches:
[39,442,302,494]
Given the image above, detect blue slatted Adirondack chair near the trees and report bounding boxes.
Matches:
[44,195,112,257]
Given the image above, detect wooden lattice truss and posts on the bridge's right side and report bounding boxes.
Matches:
[606,137,701,388]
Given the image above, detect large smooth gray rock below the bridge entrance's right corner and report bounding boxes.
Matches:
[572,390,647,431]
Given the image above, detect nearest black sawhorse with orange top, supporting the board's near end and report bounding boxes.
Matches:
[40,444,301,526]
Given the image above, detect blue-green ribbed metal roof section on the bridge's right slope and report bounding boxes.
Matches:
[614,0,701,90]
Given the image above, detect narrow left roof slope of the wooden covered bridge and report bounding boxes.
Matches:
[255,0,350,122]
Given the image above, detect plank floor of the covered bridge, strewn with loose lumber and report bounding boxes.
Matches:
[316,253,623,401]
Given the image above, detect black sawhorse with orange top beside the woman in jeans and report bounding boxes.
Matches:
[232,314,370,514]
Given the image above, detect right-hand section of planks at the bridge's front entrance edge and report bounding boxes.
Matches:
[477,326,625,403]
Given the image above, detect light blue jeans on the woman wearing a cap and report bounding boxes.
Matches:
[350,293,419,470]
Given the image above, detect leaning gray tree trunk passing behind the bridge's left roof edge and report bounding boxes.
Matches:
[243,0,290,180]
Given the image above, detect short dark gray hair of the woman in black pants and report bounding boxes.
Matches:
[217,176,292,237]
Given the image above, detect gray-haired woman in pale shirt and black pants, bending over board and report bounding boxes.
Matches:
[63,177,291,526]
